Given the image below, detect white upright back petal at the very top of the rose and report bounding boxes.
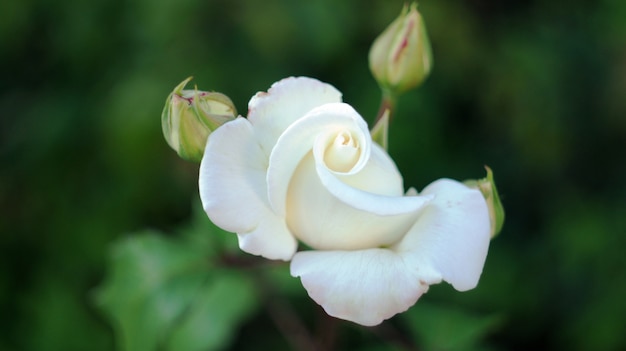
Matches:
[248,77,341,155]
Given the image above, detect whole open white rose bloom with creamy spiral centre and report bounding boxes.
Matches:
[199,77,490,326]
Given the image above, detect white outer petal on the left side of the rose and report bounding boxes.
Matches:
[199,118,297,260]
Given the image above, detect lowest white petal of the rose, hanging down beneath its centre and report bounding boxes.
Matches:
[291,249,428,326]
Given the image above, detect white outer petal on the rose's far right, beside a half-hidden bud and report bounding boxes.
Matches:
[393,179,490,291]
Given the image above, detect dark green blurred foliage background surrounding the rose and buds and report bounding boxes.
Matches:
[0,0,626,350]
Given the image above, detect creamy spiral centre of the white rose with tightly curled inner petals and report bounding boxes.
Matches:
[278,104,430,250]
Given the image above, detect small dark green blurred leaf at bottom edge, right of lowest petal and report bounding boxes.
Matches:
[401,301,502,351]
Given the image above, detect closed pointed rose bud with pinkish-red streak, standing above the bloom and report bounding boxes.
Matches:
[369,3,432,95]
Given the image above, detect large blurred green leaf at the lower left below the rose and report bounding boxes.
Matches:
[96,232,254,351]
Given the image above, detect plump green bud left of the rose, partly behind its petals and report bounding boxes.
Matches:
[161,77,237,162]
